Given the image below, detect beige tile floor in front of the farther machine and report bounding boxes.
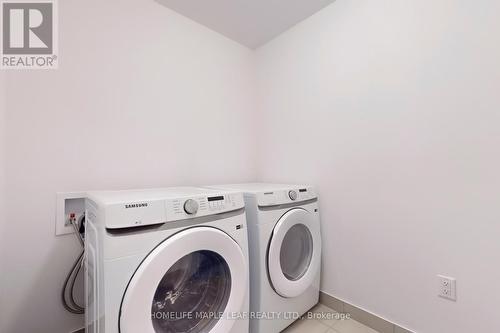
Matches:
[282,304,378,333]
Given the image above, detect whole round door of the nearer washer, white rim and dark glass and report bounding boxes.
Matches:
[120,227,248,333]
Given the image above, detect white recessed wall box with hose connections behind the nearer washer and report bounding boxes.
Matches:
[56,192,86,236]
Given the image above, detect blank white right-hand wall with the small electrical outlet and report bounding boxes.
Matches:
[257,0,500,333]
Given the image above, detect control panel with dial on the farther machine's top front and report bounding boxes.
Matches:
[257,186,318,207]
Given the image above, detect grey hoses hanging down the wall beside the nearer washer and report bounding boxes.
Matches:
[61,214,85,314]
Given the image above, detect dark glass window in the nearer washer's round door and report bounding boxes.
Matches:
[151,250,231,333]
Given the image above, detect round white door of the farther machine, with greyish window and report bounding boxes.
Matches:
[267,208,321,298]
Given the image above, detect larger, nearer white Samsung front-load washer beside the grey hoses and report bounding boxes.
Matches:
[85,187,254,333]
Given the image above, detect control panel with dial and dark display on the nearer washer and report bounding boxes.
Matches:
[165,192,245,222]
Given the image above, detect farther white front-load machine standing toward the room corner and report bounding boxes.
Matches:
[206,184,321,333]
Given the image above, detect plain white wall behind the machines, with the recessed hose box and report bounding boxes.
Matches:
[0,0,256,333]
